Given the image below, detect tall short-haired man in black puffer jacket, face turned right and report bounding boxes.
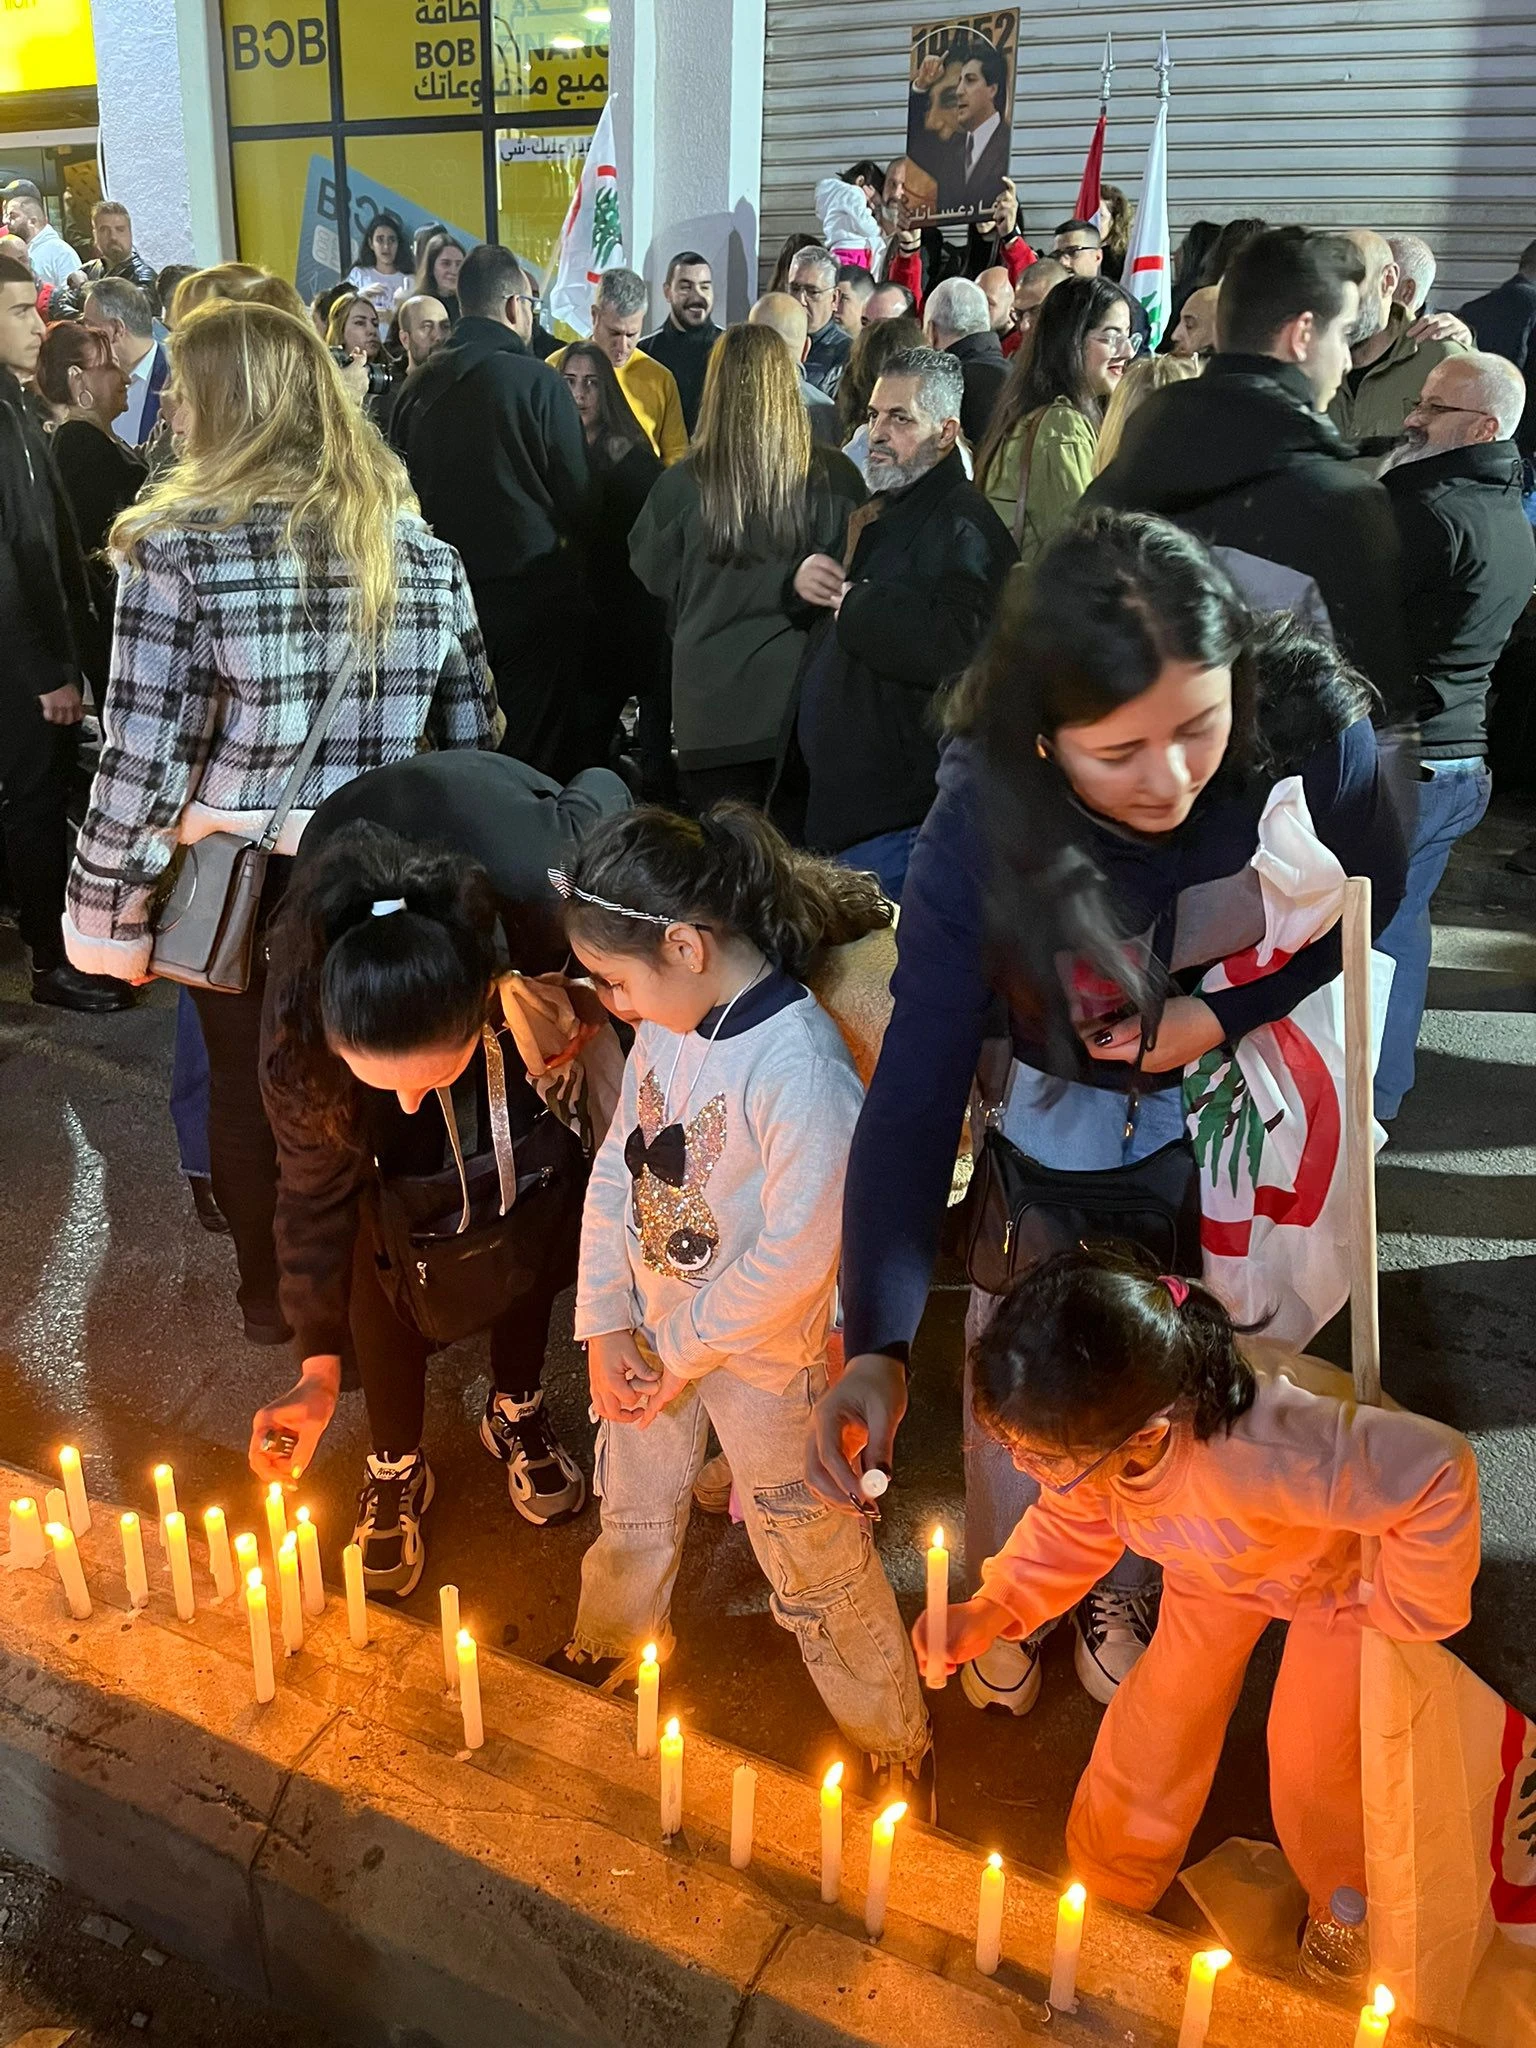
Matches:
[1083,227,1413,723]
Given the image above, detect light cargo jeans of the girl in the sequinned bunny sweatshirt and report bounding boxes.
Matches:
[573,1366,928,1763]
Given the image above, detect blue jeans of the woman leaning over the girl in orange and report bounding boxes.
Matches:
[963,1061,1184,1591]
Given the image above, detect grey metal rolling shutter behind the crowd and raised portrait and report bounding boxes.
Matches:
[760,0,1536,307]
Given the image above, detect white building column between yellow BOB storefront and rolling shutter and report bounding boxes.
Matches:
[608,0,766,324]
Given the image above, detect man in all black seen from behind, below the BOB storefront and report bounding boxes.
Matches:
[389,242,590,780]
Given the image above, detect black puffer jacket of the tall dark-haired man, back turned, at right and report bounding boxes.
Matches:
[1083,354,1413,723]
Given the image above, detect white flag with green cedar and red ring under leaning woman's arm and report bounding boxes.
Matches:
[1184,776,1393,1350]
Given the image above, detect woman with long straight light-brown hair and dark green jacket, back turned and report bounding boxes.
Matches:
[629,326,864,809]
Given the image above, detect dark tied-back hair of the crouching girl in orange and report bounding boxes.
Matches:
[975,1243,1257,1454]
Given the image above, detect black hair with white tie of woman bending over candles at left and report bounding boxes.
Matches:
[262,823,500,1143]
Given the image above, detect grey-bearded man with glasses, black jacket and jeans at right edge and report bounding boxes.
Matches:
[1376,354,1536,1124]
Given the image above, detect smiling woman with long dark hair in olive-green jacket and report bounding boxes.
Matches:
[977,276,1141,567]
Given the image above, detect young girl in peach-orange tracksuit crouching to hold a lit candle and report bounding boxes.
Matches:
[913,1247,1479,1913]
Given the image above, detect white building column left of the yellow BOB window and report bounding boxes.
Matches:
[92,0,236,268]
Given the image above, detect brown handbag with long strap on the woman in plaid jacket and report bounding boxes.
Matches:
[150,653,356,995]
